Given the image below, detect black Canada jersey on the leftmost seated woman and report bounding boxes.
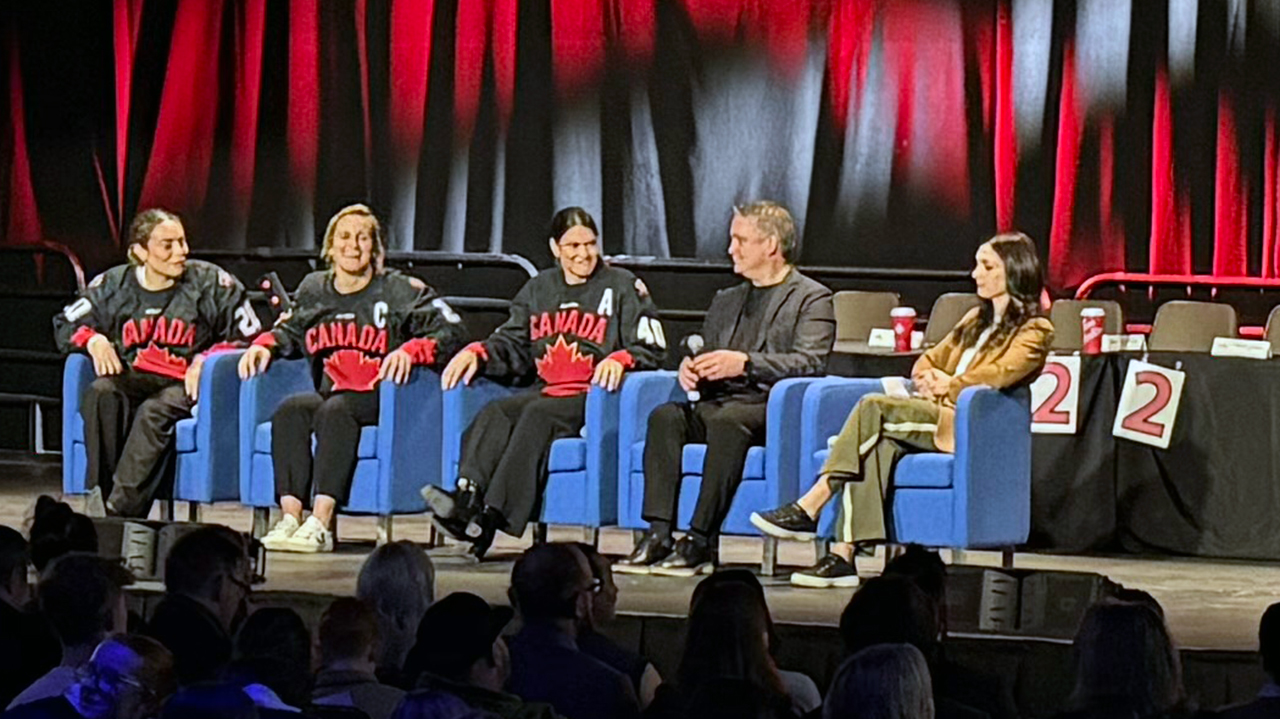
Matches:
[54,260,262,380]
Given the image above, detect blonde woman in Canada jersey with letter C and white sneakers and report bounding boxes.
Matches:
[239,205,463,553]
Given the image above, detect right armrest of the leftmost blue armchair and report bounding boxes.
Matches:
[195,349,244,481]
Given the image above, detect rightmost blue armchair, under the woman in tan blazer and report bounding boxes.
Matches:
[801,379,1032,555]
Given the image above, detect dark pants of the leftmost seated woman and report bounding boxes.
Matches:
[81,370,191,517]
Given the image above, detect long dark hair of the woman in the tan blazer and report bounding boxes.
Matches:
[952,232,1044,347]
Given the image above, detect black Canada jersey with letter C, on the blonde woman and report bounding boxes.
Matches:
[255,270,465,391]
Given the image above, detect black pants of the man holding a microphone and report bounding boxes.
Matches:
[641,400,767,539]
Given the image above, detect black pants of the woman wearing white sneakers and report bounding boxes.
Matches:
[271,390,378,505]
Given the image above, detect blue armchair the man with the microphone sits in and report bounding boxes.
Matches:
[618,371,818,574]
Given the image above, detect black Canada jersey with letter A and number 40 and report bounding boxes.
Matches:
[467,262,667,397]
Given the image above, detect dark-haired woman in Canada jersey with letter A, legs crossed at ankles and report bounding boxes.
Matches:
[422,207,667,557]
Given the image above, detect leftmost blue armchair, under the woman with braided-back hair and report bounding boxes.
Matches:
[63,351,242,521]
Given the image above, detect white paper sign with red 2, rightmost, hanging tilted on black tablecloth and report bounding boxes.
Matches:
[1111,360,1187,449]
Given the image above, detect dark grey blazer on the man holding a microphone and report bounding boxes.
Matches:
[703,267,836,393]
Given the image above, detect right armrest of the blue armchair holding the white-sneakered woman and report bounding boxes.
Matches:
[378,367,443,505]
